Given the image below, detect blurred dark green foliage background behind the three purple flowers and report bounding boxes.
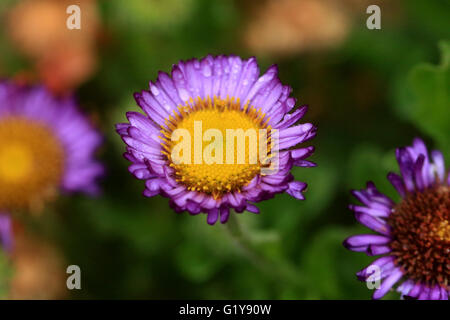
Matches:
[0,0,450,299]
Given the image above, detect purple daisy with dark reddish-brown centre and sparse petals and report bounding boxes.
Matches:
[344,138,450,300]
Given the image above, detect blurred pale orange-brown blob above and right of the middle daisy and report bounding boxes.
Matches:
[244,0,350,55]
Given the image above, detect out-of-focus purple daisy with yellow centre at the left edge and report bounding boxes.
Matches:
[0,82,103,212]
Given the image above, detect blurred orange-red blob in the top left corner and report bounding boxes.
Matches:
[6,0,100,94]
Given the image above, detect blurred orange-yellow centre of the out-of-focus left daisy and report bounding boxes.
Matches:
[0,117,64,210]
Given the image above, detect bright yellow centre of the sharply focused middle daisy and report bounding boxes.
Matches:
[161,97,271,199]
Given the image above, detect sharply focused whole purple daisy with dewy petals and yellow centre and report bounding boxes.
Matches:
[116,55,316,224]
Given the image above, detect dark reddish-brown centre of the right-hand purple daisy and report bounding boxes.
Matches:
[388,186,450,290]
